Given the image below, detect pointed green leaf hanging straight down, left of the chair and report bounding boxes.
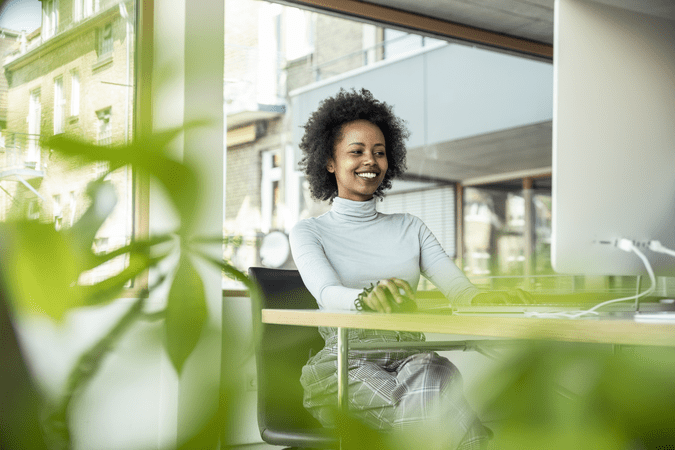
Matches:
[165,255,207,374]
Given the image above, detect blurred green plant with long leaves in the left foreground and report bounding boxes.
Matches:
[0,127,256,449]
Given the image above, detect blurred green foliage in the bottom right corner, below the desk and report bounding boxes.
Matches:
[473,342,675,450]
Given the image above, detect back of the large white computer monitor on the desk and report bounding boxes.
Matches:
[551,0,675,276]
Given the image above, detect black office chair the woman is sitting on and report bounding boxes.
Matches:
[249,267,339,449]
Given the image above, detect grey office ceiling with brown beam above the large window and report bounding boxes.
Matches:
[282,0,675,60]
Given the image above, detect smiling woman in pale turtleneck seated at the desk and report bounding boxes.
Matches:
[290,89,496,450]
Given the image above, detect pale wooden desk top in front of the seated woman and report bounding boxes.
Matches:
[262,309,675,346]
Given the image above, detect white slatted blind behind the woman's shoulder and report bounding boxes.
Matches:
[376,186,456,258]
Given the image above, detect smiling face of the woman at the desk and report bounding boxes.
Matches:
[326,120,389,202]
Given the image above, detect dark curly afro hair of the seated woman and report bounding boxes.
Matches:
[300,89,410,202]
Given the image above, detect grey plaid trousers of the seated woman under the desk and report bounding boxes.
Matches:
[300,328,488,450]
